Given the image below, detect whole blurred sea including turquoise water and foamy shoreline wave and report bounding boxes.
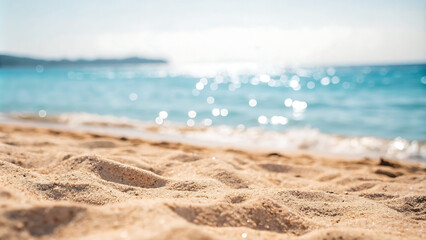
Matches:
[0,63,426,161]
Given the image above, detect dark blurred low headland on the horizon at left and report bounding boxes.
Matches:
[0,54,167,68]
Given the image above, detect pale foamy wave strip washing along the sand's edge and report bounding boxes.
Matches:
[0,113,426,161]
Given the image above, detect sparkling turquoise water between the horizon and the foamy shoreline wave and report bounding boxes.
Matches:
[0,62,426,141]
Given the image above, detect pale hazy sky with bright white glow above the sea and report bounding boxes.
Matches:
[0,0,426,65]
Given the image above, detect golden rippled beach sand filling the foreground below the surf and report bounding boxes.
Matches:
[0,125,426,239]
